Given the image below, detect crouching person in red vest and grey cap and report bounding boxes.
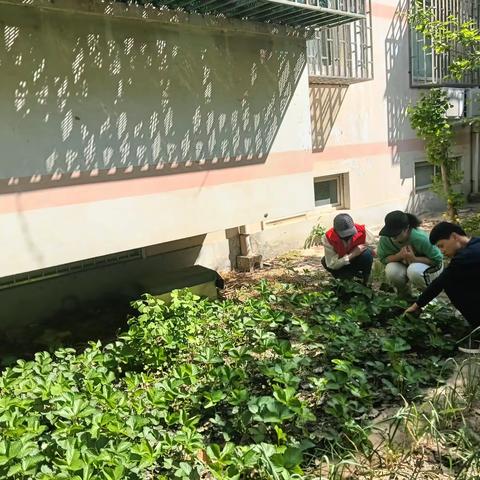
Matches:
[322,213,376,285]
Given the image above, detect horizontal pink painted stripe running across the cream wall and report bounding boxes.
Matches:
[0,135,468,214]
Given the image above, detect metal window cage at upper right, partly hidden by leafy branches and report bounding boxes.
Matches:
[410,0,480,87]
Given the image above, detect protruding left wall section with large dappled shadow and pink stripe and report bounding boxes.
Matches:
[0,1,313,276]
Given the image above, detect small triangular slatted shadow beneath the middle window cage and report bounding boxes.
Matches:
[310,84,348,152]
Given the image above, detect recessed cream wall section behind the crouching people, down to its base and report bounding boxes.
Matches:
[246,0,470,257]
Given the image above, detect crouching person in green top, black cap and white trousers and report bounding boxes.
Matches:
[377,210,443,295]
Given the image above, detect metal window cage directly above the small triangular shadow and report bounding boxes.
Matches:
[307,2,373,84]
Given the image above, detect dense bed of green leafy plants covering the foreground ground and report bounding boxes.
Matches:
[0,274,477,480]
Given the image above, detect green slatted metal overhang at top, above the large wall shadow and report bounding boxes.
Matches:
[118,0,365,29]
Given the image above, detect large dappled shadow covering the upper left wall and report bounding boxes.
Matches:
[0,6,305,193]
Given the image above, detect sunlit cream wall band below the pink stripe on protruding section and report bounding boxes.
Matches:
[1,174,311,275]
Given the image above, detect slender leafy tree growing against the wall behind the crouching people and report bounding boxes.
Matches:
[407,88,463,222]
